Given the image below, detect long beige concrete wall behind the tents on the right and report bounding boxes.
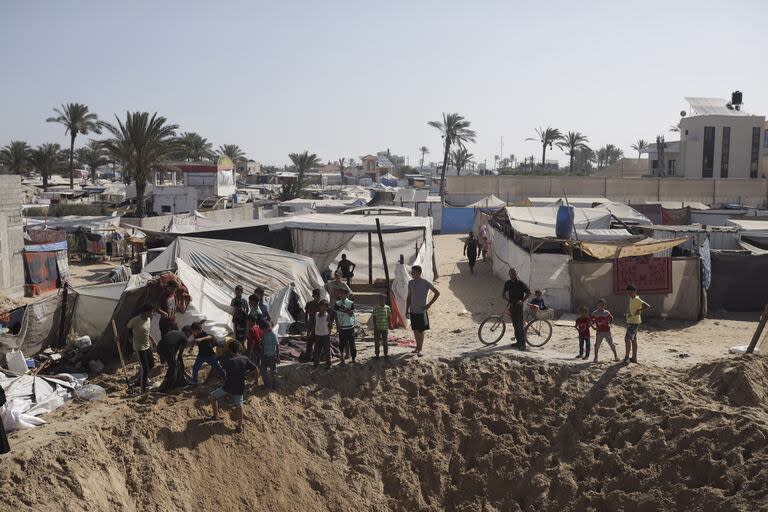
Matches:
[446,176,768,207]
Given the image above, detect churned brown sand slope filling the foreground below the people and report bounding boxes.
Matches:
[0,356,768,512]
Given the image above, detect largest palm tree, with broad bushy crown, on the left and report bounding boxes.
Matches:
[103,112,179,217]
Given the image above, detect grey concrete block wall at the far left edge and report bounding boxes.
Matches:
[0,175,24,297]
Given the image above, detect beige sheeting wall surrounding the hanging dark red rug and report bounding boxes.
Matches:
[570,258,701,320]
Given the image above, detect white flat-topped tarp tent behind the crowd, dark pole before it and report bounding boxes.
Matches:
[269,214,434,280]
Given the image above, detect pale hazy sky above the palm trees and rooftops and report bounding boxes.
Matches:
[0,0,768,165]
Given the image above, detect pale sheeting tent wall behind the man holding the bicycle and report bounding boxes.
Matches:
[490,228,571,311]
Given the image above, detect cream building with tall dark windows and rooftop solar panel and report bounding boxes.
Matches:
[664,98,765,179]
